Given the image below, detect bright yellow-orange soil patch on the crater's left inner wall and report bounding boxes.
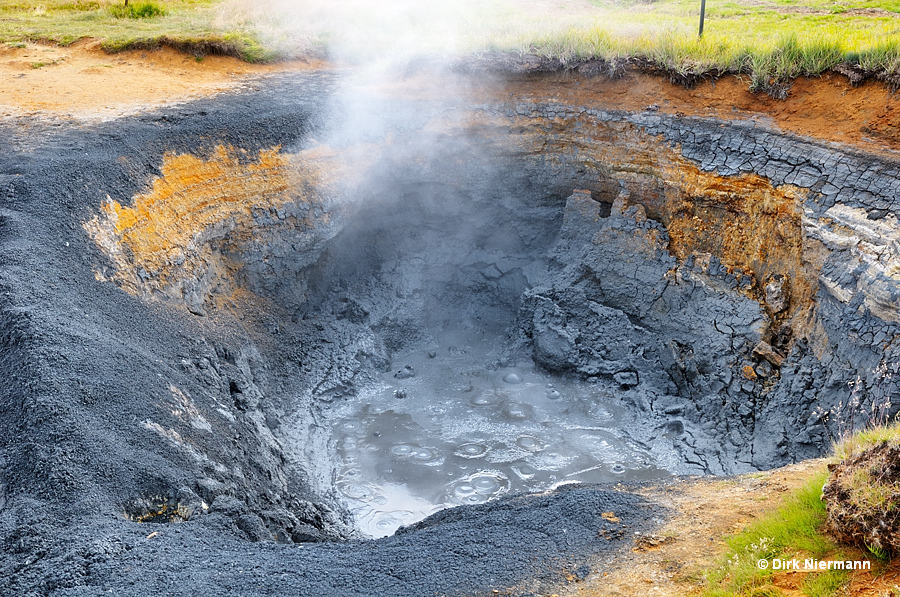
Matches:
[84,146,341,308]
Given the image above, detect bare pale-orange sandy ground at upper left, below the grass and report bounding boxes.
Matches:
[0,41,318,119]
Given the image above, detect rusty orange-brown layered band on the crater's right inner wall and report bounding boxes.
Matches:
[502,111,817,330]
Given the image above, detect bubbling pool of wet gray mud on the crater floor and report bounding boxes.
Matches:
[329,339,668,537]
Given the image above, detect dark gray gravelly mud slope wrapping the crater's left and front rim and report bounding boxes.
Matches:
[0,75,659,596]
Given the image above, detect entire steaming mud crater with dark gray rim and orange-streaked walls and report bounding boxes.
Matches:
[0,64,900,597]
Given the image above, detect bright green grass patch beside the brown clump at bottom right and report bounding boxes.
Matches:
[703,471,849,597]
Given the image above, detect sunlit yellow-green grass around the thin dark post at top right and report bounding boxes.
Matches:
[502,0,900,92]
